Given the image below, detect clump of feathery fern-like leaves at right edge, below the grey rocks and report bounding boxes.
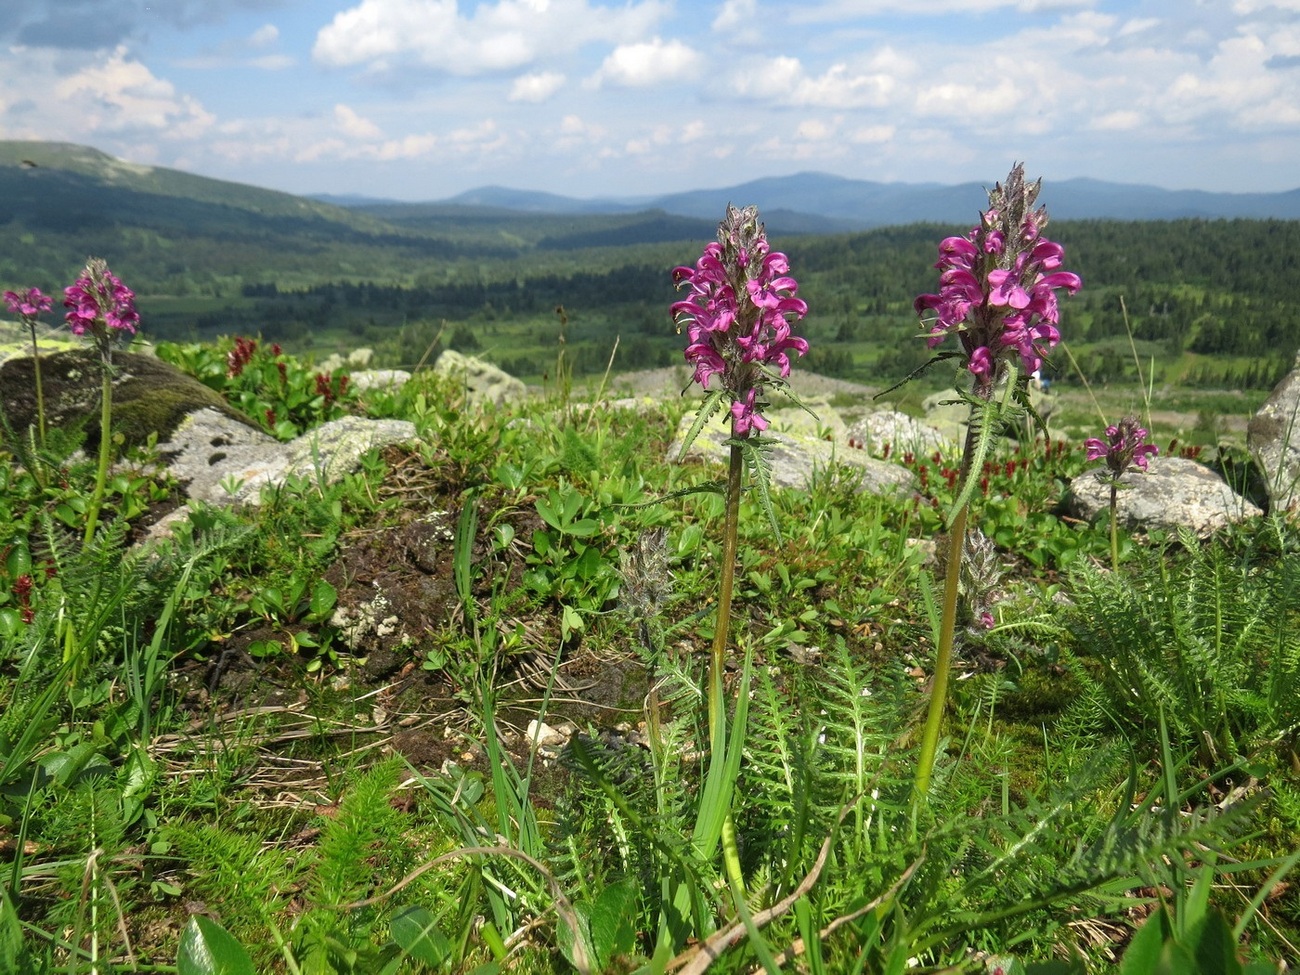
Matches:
[1067,520,1300,770]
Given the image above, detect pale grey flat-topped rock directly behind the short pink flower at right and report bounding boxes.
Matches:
[1069,456,1262,538]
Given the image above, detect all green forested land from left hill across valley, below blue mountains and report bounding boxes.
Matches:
[0,143,1300,385]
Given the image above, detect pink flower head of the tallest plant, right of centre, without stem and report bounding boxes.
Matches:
[915,165,1083,399]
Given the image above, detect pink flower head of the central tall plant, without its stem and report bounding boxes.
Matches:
[671,205,809,437]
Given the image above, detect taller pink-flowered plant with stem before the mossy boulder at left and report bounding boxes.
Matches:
[64,257,140,545]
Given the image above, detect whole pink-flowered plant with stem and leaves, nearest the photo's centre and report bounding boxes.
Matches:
[671,205,809,946]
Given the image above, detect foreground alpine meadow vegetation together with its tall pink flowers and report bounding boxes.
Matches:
[0,175,1300,975]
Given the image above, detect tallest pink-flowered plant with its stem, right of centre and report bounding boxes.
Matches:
[914,164,1082,801]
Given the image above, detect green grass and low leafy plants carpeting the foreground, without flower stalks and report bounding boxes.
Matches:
[0,340,1300,975]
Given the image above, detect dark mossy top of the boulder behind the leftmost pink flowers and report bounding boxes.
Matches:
[0,348,256,451]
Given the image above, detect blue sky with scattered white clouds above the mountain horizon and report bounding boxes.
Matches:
[0,0,1300,200]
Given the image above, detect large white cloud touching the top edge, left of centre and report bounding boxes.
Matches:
[312,0,671,75]
